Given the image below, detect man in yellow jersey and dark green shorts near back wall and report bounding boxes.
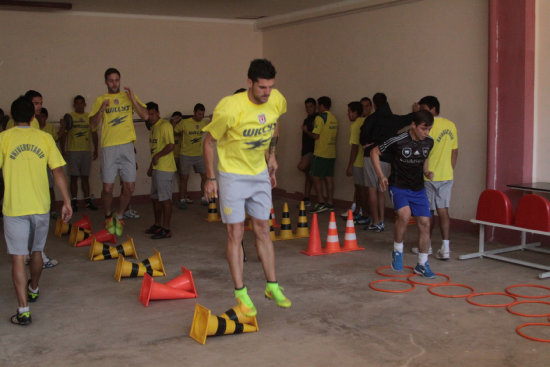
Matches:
[310,96,338,213]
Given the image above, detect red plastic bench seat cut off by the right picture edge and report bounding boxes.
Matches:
[514,194,550,232]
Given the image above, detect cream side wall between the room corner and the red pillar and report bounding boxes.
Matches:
[263,0,488,219]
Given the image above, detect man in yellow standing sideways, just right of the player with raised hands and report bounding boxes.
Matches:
[145,102,176,240]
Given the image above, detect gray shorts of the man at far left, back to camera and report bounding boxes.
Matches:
[4,213,50,255]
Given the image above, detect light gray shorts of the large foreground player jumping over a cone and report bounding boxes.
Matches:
[218,169,272,224]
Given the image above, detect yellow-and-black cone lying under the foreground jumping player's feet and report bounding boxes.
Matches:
[189,303,258,344]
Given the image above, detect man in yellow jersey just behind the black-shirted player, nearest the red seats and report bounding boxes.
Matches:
[412,96,458,260]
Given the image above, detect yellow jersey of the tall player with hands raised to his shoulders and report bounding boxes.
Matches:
[90,92,146,148]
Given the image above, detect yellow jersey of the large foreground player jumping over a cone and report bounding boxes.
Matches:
[203,89,286,175]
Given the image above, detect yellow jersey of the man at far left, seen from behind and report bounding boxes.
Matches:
[0,126,65,217]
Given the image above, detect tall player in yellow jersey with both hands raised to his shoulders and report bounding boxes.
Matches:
[90,68,149,236]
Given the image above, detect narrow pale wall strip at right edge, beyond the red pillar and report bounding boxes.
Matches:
[533,1,550,182]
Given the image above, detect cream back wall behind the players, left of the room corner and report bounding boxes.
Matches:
[0,11,262,197]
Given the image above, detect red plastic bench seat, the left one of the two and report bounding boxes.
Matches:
[476,189,514,225]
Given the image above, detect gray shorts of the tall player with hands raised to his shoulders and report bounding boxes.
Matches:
[101,143,136,183]
